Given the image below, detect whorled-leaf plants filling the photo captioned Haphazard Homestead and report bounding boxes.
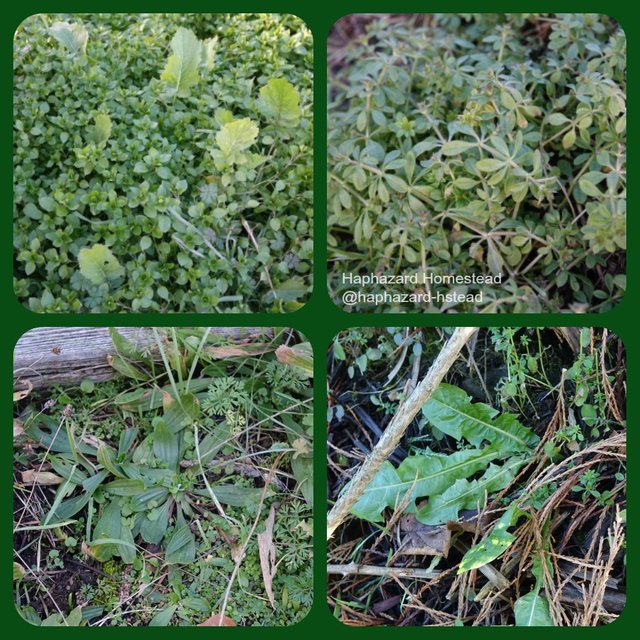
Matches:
[328,14,626,312]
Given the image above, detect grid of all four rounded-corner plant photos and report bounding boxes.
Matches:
[13,13,627,627]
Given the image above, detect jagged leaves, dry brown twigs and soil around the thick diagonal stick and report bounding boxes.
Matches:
[328,328,626,626]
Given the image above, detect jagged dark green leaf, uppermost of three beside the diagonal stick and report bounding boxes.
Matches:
[422,384,539,452]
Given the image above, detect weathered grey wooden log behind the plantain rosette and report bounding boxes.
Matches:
[13,327,273,390]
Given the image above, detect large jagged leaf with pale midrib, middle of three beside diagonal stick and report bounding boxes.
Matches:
[351,448,499,522]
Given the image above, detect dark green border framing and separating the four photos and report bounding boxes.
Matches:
[5,0,640,638]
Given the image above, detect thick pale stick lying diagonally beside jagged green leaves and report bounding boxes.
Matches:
[327,327,478,540]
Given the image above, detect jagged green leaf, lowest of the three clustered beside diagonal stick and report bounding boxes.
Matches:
[416,458,526,524]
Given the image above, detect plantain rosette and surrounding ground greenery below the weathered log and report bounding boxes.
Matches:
[14,329,313,626]
